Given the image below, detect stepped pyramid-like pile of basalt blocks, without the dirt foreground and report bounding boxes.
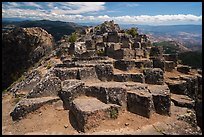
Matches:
[7,21,202,132]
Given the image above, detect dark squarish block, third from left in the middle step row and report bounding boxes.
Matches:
[95,64,113,81]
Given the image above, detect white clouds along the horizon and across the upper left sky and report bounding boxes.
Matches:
[2,2,202,25]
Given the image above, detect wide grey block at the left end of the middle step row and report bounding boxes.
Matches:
[54,68,78,81]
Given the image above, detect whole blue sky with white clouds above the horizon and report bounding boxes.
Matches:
[2,2,202,25]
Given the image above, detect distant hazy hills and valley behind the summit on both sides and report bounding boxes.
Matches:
[2,18,202,50]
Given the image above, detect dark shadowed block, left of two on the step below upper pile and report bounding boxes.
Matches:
[114,60,135,71]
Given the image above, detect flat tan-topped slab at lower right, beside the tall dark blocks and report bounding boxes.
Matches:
[171,94,195,109]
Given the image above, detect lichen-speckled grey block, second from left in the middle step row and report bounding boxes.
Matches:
[78,67,97,80]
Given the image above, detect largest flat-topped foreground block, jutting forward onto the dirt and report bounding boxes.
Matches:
[70,97,119,132]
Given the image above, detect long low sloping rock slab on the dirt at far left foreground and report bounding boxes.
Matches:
[10,97,60,120]
